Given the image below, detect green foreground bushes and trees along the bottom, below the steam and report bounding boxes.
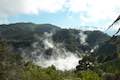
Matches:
[0,41,120,80]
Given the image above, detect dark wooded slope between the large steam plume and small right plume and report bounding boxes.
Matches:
[53,29,90,53]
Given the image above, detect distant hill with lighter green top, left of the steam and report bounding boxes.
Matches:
[0,23,60,48]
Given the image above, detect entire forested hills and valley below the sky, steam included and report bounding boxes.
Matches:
[0,23,120,80]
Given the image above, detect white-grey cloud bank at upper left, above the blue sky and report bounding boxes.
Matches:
[0,0,66,16]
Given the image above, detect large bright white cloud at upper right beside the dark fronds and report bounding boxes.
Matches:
[68,0,120,28]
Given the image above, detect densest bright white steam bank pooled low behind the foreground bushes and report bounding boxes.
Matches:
[36,53,80,71]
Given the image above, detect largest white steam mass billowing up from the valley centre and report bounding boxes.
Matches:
[32,33,80,71]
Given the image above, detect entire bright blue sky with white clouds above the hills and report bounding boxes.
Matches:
[0,0,120,32]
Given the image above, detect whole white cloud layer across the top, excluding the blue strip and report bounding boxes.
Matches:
[0,0,120,30]
